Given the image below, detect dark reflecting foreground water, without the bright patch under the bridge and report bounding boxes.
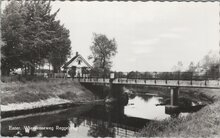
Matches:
[1,105,149,137]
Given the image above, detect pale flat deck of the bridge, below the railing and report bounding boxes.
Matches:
[79,78,220,89]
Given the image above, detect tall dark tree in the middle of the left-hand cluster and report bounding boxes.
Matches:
[21,1,60,74]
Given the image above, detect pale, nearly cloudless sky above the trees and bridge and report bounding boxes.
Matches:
[1,1,220,71]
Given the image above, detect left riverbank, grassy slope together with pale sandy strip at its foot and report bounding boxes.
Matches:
[1,79,95,115]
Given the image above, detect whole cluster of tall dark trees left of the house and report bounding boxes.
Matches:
[2,0,71,75]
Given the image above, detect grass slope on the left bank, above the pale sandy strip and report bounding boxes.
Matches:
[1,79,94,105]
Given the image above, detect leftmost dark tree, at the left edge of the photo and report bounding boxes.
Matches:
[1,1,24,75]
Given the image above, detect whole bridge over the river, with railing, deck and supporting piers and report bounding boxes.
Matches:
[79,72,220,110]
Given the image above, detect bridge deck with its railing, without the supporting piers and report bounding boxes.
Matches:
[79,72,220,89]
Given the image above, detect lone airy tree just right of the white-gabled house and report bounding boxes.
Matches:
[89,33,117,77]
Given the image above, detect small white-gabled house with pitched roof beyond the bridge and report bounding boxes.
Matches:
[62,52,92,77]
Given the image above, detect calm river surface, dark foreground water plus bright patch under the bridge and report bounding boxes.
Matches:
[1,95,205,137]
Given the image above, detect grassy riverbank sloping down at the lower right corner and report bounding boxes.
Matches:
[138,88,220,137]
